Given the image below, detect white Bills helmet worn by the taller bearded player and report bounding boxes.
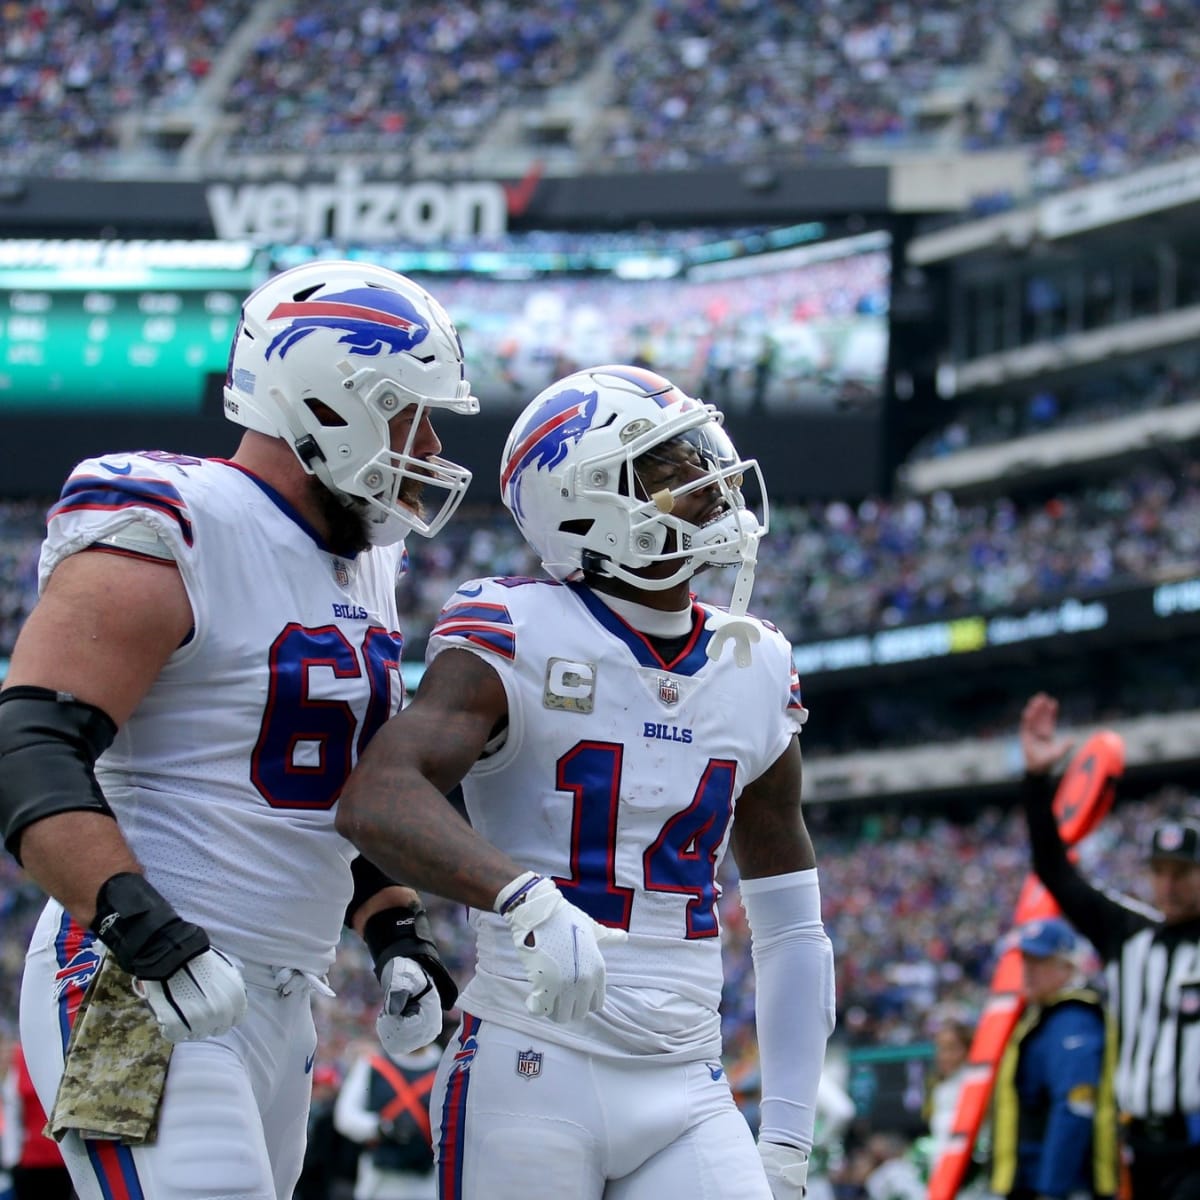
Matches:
[224,260,479,546]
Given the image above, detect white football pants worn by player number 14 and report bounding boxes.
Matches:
[430,1014,770,1200]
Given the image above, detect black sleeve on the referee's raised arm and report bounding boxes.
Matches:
[1021,774,1153,962]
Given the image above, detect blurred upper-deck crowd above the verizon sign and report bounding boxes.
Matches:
[7,0,1200,190]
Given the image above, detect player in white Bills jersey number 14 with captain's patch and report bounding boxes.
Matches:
[337,366,834,1200]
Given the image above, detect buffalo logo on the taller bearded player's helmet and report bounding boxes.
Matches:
[266,288,430,359]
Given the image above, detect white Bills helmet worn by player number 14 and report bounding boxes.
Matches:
[500,365,768,590]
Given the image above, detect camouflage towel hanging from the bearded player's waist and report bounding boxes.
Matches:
[46,954,172,1146]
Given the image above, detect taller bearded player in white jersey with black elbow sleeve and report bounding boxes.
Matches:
[0,262,479,1200]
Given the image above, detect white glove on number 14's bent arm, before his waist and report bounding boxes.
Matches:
[496,871,628,1022]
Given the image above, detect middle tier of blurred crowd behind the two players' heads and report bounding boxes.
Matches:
[0,448,1200,700]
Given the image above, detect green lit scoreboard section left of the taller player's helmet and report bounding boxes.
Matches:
[0,242,265,415]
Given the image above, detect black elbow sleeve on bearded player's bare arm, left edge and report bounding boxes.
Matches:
[0,686,116,863]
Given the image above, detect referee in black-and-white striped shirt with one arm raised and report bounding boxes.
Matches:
[1020,692,1200,1200]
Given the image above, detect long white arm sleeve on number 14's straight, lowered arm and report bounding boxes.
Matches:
[742,868,835,1151]
